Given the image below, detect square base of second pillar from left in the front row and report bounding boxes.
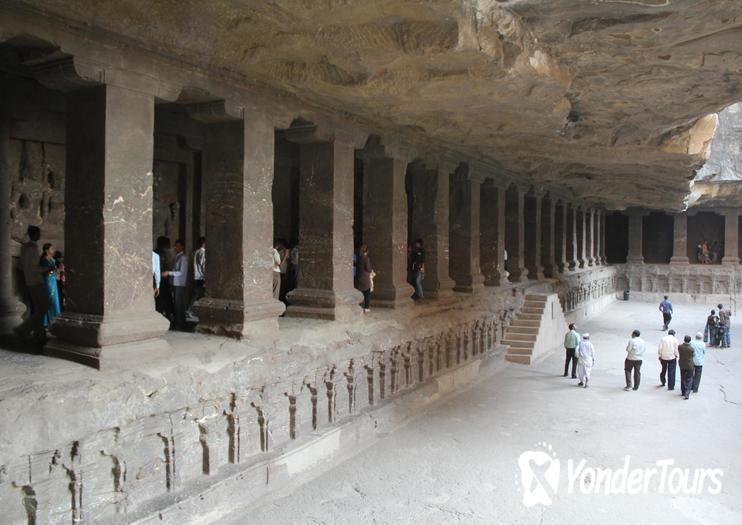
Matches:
[193,297,286,344]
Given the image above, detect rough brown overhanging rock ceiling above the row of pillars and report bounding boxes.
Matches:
[17,0,742,208]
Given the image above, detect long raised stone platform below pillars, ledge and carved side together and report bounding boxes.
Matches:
[0,268,611,524]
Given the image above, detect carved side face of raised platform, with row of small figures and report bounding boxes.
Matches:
[0,289,524,524]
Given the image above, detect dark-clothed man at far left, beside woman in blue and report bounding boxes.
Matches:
[15,226,49,343]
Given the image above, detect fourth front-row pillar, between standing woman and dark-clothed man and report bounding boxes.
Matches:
[363,145,413,308]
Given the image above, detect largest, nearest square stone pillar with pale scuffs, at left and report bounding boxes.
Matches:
[45,85,169,368]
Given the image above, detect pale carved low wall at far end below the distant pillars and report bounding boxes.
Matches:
[616,264,742,306]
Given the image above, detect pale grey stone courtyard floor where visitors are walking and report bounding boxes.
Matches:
[232,302,742,525]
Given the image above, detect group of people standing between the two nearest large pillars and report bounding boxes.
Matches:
[152,236,206,330]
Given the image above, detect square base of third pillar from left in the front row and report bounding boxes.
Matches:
[286,288,363,322]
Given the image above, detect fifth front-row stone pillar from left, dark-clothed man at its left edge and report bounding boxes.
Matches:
[412,164,454,298]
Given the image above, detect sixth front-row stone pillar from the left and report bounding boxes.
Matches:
[450,173,484,293]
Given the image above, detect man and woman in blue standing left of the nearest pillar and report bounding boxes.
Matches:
[15,226,65,343]
